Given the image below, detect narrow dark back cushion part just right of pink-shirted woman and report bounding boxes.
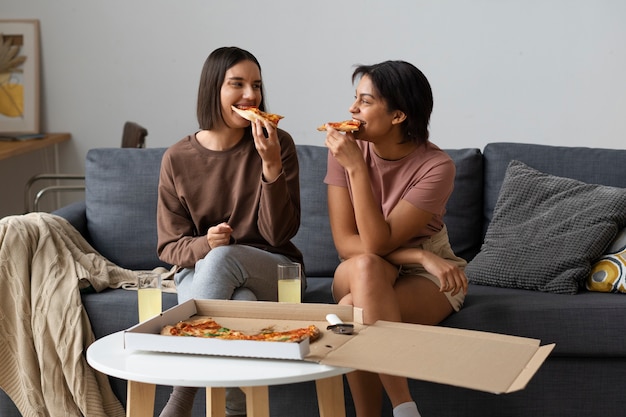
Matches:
[443,148,483,261]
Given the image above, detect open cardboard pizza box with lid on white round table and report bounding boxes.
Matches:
[124,300,555,394]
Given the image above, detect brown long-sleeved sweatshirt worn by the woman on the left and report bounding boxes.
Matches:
[157,129,302,268]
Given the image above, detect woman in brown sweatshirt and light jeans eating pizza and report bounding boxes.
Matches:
[157,47,305,417]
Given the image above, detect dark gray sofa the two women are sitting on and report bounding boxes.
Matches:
[0,143,626,417]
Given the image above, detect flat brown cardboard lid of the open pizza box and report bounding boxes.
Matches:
[320,321,554,394]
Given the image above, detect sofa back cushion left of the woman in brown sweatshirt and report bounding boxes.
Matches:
[85,148,167,269]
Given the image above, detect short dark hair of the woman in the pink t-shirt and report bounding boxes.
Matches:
[352,61,433,144]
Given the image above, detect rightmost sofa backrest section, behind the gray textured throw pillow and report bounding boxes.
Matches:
[483,142,626,231]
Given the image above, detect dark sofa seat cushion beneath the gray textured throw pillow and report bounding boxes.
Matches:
[441,284,626,356]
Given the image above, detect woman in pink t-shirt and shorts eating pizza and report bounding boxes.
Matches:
[325,61,467,417]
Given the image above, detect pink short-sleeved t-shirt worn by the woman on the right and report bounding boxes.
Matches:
[324,140,456,246]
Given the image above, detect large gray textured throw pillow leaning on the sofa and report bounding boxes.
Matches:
[465,161,626,294]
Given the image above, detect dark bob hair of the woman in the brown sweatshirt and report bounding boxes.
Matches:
[197,46,265,130]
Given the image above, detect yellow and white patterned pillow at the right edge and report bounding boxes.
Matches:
[586,229,626,293]
